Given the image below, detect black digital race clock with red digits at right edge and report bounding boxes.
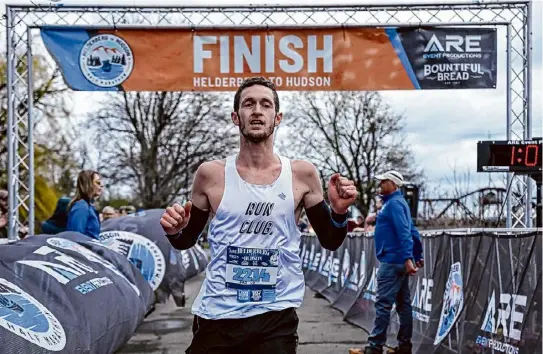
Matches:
[477,140,541,174]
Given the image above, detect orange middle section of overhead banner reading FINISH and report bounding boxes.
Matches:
[111,29,413,91]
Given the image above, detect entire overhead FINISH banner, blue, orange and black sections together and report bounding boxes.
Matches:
[41,27,497,91]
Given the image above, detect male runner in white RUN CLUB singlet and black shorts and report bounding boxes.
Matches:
[160,77,358,354]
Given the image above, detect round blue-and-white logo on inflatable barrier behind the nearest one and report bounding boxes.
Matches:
[100,231,166,290]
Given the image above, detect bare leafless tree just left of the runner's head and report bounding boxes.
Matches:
[87,92,237,208]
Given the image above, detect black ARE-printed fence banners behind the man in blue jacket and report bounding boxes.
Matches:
[301,229,543,354]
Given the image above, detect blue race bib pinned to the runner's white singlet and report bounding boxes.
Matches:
[226,246,279,302]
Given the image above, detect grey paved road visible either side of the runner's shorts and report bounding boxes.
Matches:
[117,274,367,354]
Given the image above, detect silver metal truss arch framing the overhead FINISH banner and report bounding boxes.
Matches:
[6,1,532,240]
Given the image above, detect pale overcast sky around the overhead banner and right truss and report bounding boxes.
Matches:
[0,0,543,196]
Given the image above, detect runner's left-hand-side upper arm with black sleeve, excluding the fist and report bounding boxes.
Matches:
[166,163,211,250]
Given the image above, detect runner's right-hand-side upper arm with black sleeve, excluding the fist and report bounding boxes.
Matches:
[299,161,347,251]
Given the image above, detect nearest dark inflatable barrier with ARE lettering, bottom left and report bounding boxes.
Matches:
[0,232,154,354]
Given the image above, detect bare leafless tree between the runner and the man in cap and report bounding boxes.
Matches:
[281,91,421,215]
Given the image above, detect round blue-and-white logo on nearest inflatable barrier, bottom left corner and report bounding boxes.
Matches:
[0,278,66,352]
